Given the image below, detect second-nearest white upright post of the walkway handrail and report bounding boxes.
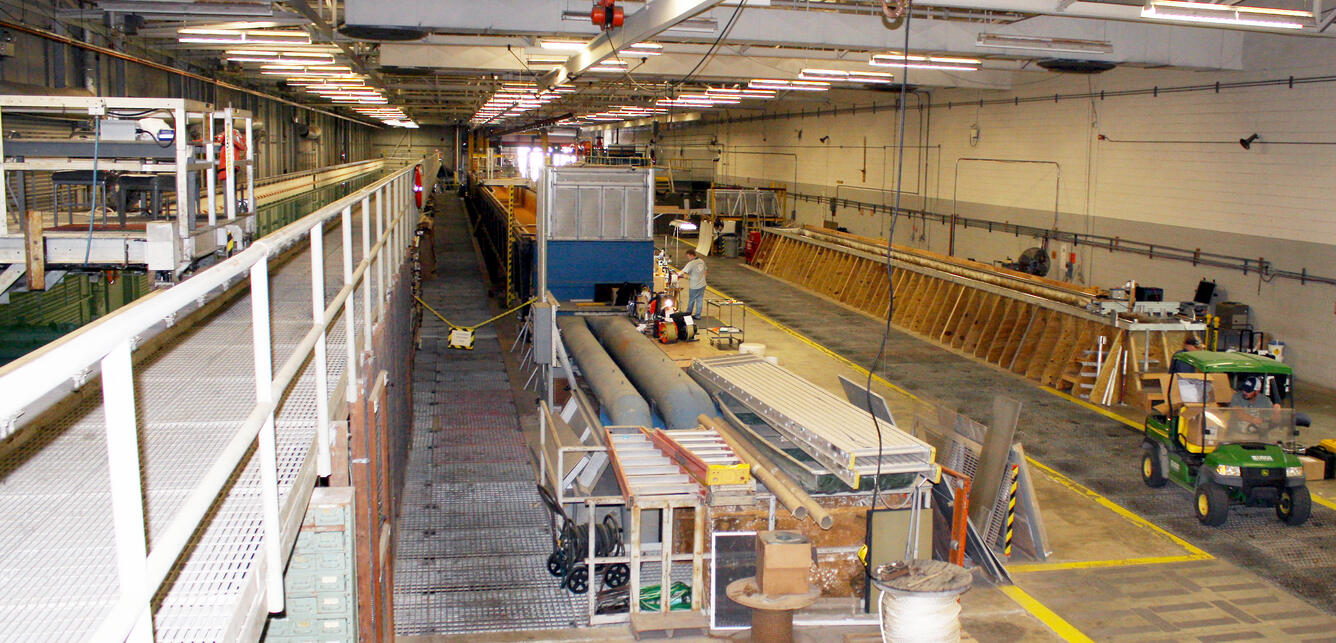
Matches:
[250,257,283,614]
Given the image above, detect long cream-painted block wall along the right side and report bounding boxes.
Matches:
[623,36,1336,386]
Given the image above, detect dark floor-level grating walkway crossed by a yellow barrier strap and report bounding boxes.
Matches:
[394,197,578,635]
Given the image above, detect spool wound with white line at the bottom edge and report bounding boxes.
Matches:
[872,560,974,643]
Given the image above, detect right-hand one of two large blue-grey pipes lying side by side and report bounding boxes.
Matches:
[588,315,719,429]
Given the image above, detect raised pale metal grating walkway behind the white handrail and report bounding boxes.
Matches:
[0,189,387,642]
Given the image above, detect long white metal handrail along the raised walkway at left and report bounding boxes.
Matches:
[0,159,417,640]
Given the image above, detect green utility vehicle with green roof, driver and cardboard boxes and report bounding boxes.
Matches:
[1141,350,1312,525]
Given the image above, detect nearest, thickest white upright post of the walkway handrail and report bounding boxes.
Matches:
[102,340,154,642]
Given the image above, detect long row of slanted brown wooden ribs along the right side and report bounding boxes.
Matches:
[752,231,1182,401]
